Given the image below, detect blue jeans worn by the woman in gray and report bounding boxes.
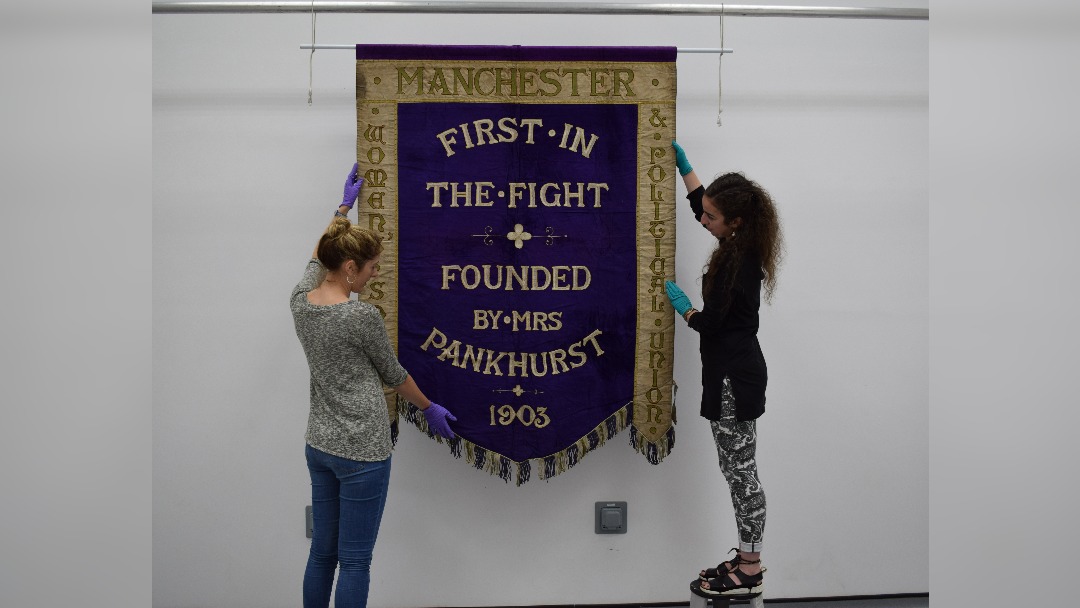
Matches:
[303,445,390,608]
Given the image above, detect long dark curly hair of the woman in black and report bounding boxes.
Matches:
[702,172,784,308]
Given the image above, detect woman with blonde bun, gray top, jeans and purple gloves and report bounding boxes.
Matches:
[289,164,457,608]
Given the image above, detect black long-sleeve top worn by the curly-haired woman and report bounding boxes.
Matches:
[687,186,769,420]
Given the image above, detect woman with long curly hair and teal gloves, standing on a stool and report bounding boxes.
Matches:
[665,141,783,596]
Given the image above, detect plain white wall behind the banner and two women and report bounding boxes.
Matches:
[153,2,929,608]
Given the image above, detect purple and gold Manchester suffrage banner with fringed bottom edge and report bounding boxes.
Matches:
[356,44,676,485]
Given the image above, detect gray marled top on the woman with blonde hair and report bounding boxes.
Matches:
[289,259,408,461]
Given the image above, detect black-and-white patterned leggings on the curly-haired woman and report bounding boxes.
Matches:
[711,378,765,553]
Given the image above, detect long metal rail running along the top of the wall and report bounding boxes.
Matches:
[152,0,930,21]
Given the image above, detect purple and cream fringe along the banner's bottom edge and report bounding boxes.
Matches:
[390,395,639,486]
